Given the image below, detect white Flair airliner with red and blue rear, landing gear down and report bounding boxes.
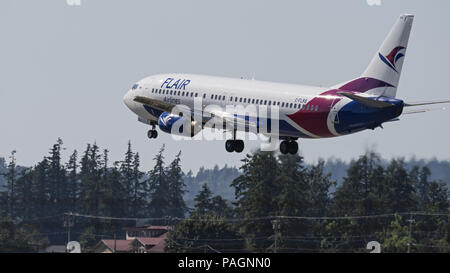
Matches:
[123,14,450,154]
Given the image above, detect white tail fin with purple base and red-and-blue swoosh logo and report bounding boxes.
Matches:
[338,14,414,98]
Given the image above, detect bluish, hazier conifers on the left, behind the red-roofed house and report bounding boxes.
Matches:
[0,139,187,251]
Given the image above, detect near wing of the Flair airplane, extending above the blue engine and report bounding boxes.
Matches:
[134,96,257,132]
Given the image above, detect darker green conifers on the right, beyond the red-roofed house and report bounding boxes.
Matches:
[166,152,450,252]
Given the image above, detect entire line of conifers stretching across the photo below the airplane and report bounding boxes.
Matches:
[0,139,450,252]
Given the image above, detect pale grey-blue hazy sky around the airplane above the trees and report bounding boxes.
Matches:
[0,0,450,171]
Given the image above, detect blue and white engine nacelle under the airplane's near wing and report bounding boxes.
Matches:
[158,112,201,137]
